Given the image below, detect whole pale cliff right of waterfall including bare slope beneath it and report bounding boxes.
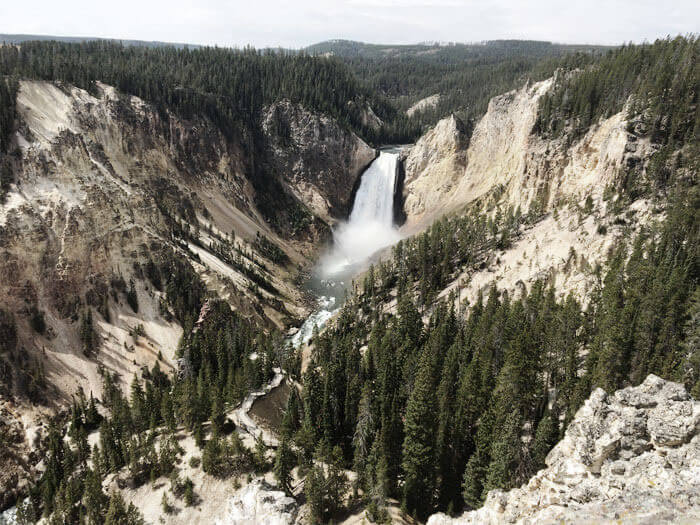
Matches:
[402,79,659,302]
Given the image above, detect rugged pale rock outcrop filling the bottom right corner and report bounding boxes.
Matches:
[428,375,700,525]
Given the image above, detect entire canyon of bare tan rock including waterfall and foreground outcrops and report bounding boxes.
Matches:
[0,37,700,525]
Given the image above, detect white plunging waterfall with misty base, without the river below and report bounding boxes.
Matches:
[321,150,399,277]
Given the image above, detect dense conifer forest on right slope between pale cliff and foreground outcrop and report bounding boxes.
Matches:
[288,182,700,518]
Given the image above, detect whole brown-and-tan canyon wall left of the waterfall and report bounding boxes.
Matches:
[0,81,374,506]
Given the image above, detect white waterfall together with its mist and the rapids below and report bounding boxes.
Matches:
[289,149,401,348]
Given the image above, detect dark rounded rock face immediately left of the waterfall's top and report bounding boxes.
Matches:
[262,100,376,222]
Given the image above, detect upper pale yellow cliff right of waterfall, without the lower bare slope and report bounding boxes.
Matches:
[404,79,653,226]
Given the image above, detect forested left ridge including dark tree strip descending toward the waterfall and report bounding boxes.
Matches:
[0,41,404,228]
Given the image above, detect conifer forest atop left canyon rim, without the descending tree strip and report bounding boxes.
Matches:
[0,42,382,138]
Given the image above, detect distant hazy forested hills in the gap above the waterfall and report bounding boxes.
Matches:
[307,40,605,133]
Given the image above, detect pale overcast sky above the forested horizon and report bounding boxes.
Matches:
[0,0,700,47]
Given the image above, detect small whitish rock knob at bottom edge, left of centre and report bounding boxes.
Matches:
[216,481,299,525]
